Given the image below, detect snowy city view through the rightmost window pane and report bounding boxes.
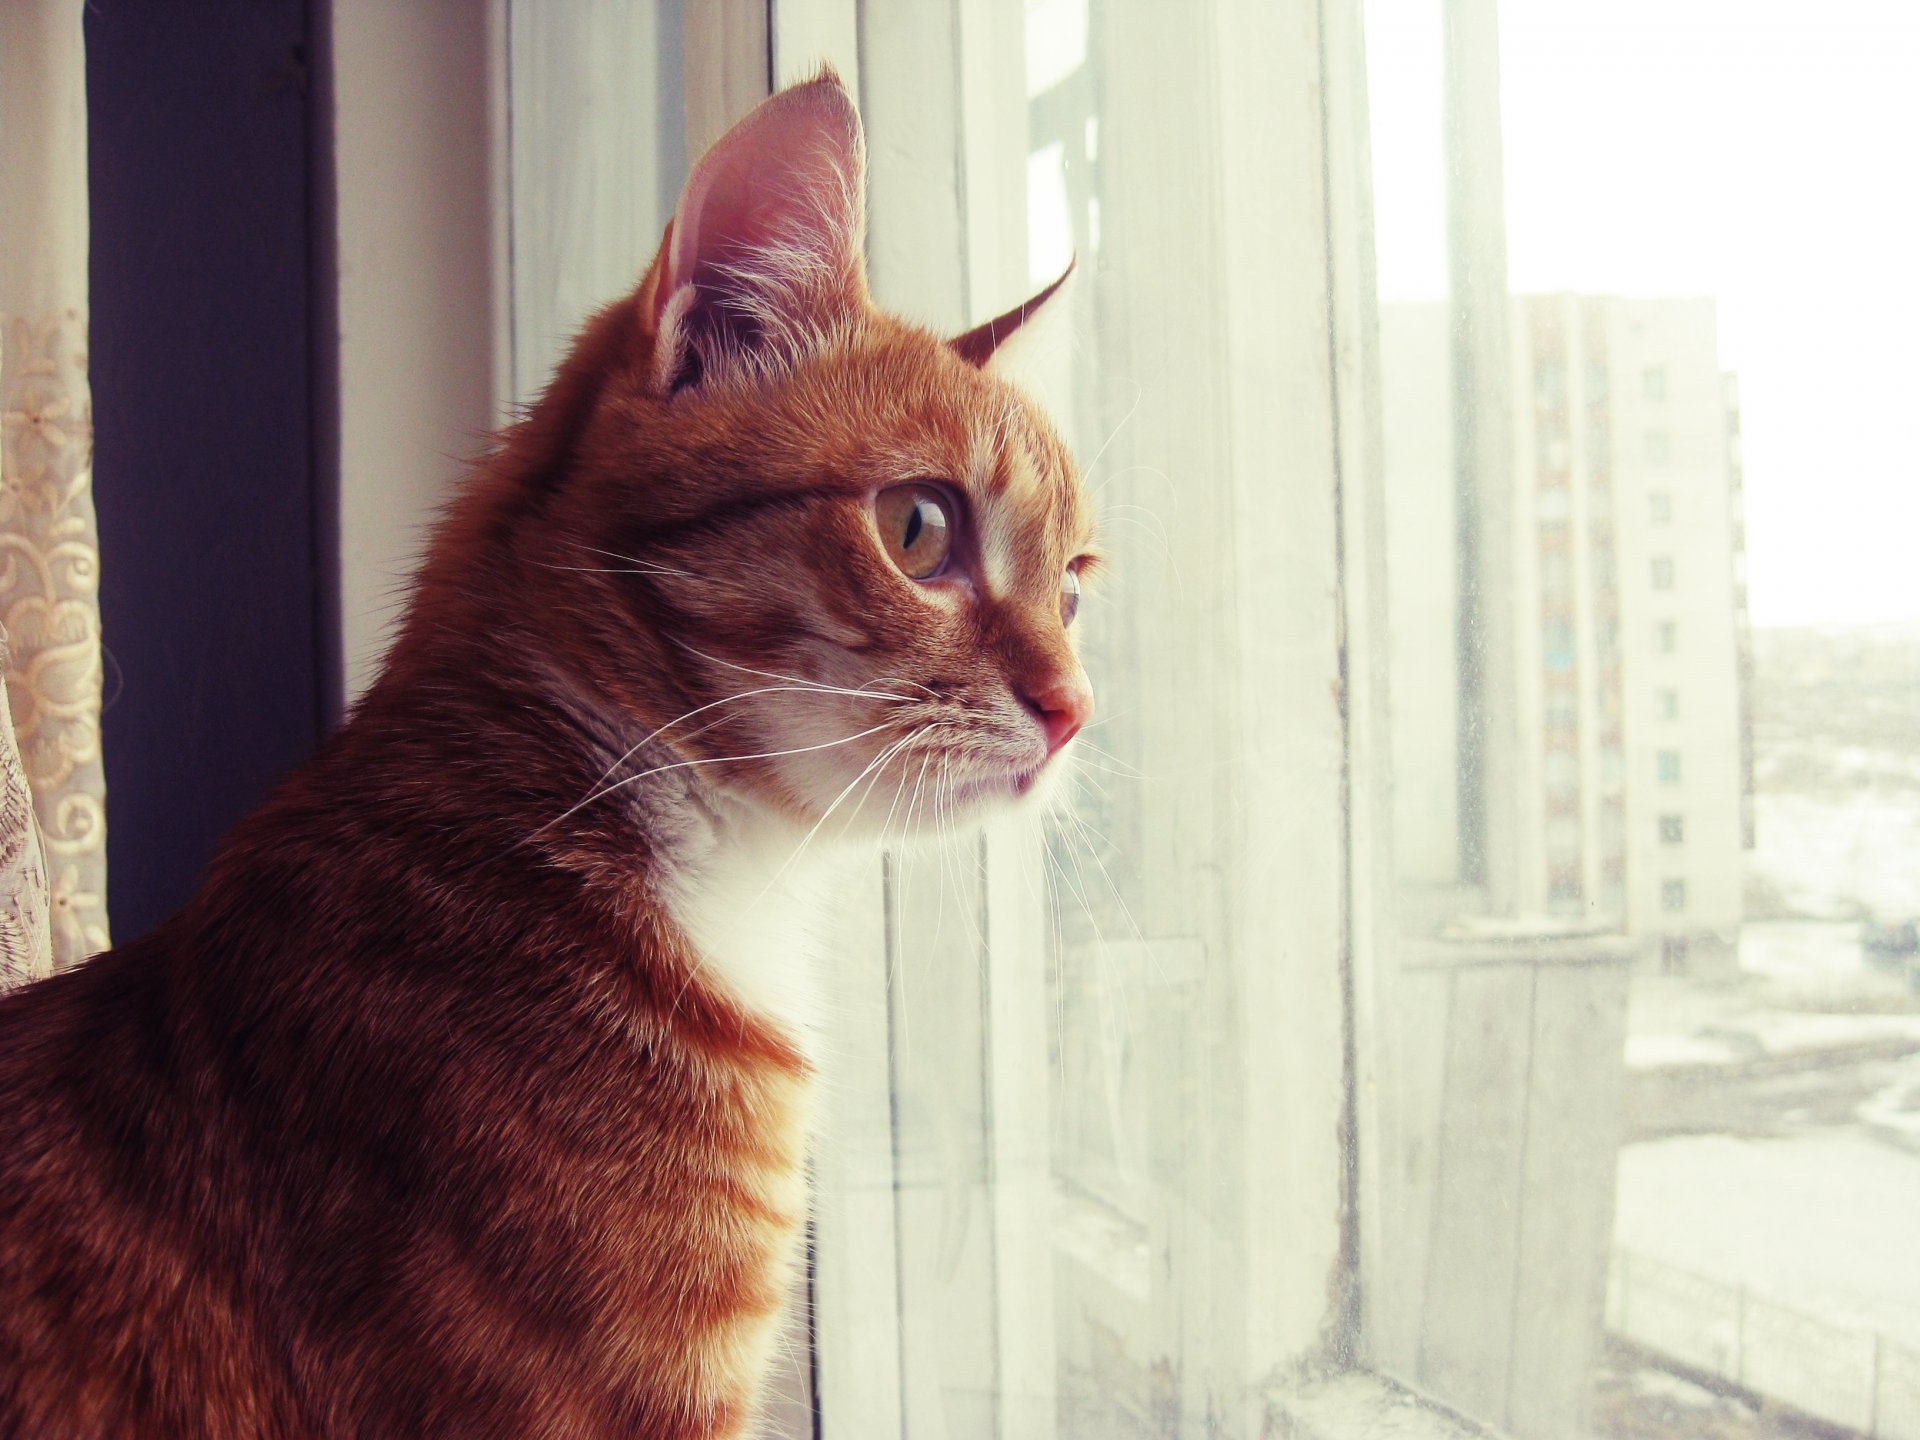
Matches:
[1369,0,1920,1440]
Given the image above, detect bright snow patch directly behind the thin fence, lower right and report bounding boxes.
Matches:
[1615,1133,1920,1350]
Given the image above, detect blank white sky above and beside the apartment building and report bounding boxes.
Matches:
[1367,0,1920,626]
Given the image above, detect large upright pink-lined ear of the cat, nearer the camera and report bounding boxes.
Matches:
[639,69,866,394]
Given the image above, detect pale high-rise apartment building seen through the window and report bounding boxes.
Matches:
[1382,296,1751,970]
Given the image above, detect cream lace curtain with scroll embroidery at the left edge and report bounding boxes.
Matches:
[0,0,108,987]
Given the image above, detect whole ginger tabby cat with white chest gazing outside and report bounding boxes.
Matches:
[0,73,1092,1440]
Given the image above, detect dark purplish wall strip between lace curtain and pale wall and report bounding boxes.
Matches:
[86,0,336,939]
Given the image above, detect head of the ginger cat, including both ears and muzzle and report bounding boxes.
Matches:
[511,73,1094,833]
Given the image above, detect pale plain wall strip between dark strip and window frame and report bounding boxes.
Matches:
[330,0,505,701]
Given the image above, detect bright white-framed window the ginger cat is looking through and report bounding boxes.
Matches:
[776,0,1920,1440]
